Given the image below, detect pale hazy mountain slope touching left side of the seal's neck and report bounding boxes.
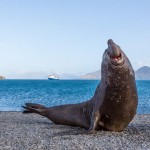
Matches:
[81,70,101,80]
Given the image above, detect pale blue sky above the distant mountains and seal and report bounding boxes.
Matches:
[0,0,150,78]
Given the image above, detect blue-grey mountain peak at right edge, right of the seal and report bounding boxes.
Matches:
[135,66,150,80]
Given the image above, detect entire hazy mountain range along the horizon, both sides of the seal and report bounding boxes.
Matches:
[5,66,150,80]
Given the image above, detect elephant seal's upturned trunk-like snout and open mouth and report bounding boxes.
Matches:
[107,39,124,66]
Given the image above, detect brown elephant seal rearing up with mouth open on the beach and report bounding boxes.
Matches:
[22,39,138,133]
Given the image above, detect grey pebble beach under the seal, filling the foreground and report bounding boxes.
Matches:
[0,112,150,150]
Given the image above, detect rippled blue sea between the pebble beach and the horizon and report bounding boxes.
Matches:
[0,80,150,114]
